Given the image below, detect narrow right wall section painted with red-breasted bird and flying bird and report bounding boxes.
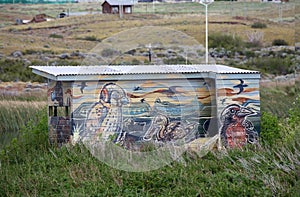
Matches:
[217,77,260,148]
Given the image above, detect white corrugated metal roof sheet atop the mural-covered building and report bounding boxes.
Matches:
[31,64,259,77]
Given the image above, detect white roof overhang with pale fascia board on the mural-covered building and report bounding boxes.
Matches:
[30,64,260,81]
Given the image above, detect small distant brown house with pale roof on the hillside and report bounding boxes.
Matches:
[102,0,134,14]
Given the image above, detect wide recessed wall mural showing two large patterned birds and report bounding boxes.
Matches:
[72,79,212,149]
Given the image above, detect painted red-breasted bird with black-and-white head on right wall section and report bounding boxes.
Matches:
[221,104,257,148]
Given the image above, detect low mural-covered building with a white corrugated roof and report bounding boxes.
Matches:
[31,65,260,148]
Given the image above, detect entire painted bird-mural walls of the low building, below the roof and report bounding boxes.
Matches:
[48,74,260,149]
